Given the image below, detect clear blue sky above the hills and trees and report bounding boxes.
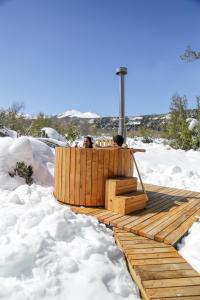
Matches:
[0,0,200,116]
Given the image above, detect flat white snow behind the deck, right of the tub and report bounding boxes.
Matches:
[127,139,200,191]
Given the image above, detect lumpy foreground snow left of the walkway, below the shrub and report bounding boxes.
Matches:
[0,184,139,300]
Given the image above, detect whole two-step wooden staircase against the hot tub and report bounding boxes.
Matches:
[105,177,148,215]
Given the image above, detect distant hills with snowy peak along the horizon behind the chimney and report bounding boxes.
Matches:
[19,109,196,135]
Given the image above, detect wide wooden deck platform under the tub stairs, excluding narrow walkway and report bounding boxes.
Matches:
[71,184,200,245]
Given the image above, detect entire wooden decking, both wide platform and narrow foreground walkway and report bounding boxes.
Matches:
[66,184,200,300]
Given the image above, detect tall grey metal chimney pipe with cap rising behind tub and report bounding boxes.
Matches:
[116,67,128,142]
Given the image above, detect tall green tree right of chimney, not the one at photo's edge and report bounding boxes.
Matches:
[167,95,192,150]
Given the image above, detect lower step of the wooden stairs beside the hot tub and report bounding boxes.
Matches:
[112,191,147,215]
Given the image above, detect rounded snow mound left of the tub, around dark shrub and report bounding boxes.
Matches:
[0,137,54,190]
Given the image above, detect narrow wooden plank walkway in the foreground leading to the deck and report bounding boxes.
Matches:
[114,228,200,300]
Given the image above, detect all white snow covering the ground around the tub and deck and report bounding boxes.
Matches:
[0,137,200,300]
